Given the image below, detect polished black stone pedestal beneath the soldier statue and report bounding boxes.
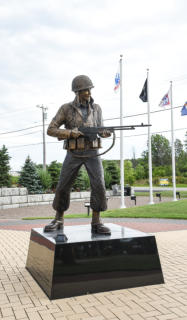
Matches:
[26,223,164,299]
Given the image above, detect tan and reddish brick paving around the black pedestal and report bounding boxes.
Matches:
[0,196,187,320]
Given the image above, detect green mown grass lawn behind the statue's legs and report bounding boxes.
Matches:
[23,200,187,220]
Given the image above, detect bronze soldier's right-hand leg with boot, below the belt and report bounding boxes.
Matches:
[85,152,111,235]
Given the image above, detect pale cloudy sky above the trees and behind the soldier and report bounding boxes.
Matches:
[0,0,187,171]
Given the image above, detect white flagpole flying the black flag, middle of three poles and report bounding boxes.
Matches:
[147,69,154,204]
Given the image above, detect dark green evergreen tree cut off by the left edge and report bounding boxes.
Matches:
[0,145,11,187]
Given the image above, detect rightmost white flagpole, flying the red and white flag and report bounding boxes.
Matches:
[170,81,177,201]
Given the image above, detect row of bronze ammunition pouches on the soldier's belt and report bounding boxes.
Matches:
[64,137,102,150]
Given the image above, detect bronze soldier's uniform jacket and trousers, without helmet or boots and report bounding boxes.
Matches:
[47,97,107,212]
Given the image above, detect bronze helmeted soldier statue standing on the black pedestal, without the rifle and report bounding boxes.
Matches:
[44,75,111,235]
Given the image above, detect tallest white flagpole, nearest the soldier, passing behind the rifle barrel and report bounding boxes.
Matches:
[120,54,126,208]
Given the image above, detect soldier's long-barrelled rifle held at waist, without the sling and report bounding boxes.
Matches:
[78,123,151,141]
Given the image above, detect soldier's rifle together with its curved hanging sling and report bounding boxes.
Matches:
[71,123,151,158]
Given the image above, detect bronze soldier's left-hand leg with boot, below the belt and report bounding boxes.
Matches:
[44,152,82,232]
